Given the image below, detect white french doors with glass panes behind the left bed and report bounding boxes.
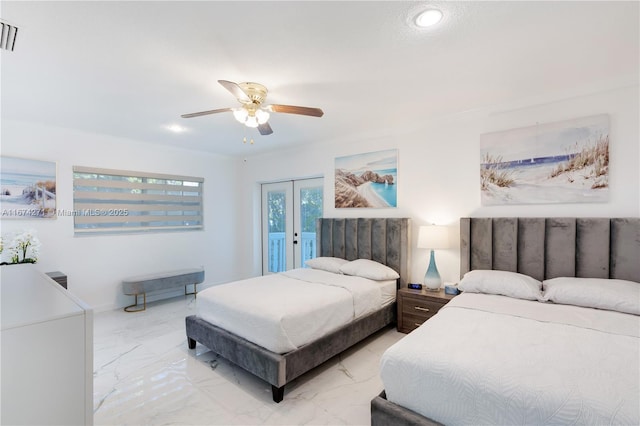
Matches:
[262,178,323,275]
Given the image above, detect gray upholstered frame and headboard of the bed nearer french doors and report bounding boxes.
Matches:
[186,218,410,402]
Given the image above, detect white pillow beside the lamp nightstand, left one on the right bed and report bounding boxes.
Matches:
[458,269,542,300]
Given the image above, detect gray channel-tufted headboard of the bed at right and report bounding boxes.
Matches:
[460,217,640,282]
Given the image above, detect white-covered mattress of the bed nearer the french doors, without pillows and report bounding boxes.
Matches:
[196,268,396,354]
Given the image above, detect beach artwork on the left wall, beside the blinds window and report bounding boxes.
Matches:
[0,156,56,219]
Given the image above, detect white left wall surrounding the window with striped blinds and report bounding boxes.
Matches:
[0,120,241,311]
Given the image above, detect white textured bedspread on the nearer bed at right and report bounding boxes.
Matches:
[381,294,640,425]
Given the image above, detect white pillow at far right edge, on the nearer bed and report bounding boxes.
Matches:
[542,277,640,315]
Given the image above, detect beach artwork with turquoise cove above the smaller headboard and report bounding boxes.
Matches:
[335,149,398,208]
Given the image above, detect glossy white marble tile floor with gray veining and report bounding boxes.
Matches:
[93,296,404,425]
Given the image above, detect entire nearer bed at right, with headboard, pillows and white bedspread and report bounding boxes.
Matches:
[371,218,640,425]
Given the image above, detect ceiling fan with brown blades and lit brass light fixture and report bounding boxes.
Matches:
[181,80,324,135]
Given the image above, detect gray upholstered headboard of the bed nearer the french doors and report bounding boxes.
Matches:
[316,218,410,287]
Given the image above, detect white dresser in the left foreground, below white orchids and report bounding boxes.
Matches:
[0,264,93,425]
